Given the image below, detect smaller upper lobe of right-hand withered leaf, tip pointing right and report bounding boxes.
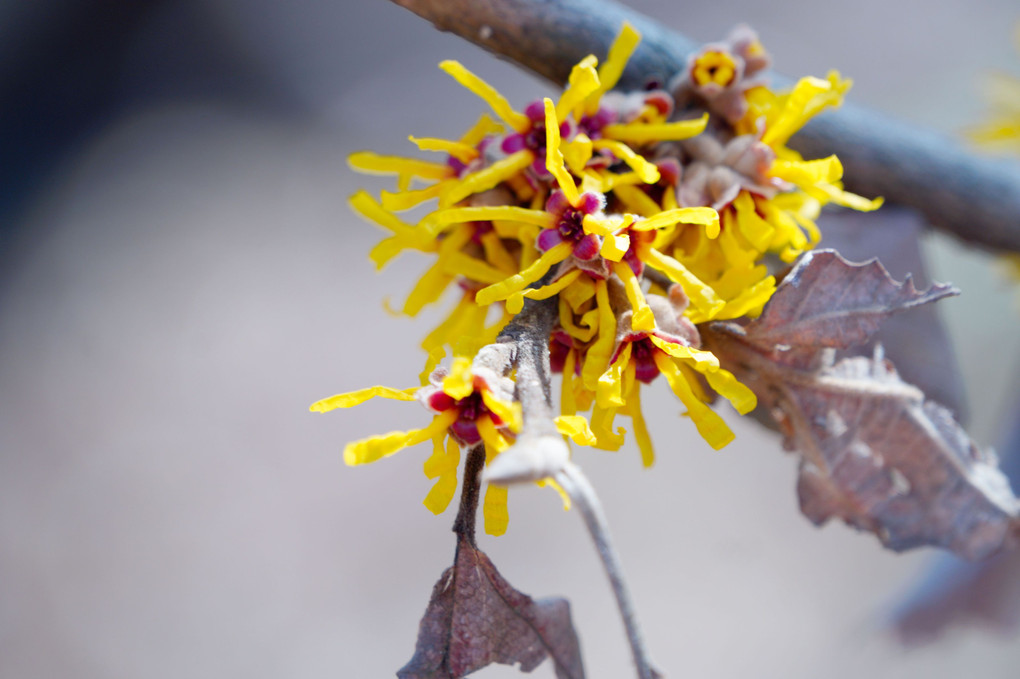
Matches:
[747,250,960,365]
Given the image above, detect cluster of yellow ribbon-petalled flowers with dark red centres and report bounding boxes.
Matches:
[313,24,880,532]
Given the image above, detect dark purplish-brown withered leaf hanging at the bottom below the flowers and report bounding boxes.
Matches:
[397,537,584,679]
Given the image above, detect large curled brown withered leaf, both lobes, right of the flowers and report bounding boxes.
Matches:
[701,253,1020,559]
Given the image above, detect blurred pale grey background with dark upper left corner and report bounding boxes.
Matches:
[0,0,1020,679]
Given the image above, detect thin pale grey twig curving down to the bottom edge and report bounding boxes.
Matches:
[556,462,657,679]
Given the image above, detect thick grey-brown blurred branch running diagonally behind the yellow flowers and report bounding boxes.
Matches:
[393,0,1020,251]
